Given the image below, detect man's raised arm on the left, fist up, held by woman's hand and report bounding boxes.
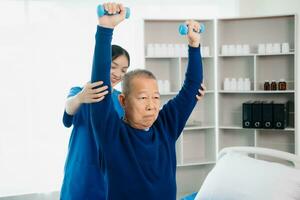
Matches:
[90,3,126,144]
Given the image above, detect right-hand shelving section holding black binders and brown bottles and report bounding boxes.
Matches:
[217,15,297,161]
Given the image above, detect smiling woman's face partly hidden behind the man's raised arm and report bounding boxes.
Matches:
[110,55,129,87]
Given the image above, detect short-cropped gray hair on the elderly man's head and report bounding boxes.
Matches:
[122,69,156,96]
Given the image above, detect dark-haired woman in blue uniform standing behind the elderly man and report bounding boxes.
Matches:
[60,45,130,200]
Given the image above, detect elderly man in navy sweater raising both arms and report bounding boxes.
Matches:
[90,3,204,200]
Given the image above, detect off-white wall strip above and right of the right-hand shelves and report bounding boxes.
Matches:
[239,0,300,155]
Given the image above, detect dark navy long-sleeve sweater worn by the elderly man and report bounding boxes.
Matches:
[90,26,202,200]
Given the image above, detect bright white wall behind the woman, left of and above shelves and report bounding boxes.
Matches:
[0,0,239,196]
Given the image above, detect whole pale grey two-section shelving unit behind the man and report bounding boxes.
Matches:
[144,15,298,198]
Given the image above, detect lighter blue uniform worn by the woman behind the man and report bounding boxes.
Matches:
[60,87,124,200]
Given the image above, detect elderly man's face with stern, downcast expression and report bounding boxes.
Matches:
[124,77,160,129]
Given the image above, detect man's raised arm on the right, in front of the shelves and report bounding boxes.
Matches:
[159,20,203,140]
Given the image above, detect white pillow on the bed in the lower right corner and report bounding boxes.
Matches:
[195,153,300,200]
